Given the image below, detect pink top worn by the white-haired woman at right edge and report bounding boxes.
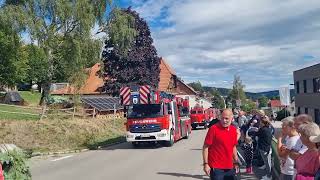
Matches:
[296,150,320,176]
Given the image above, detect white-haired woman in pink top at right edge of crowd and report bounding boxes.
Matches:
[296,123,320,180]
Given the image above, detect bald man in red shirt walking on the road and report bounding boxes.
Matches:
[202,109,238,180]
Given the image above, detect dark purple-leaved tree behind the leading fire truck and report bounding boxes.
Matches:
[103,8,160,95]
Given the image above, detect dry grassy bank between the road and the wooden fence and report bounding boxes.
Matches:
[0,118,125,152]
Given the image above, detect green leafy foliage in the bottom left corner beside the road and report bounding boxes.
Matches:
[0,150,31,180]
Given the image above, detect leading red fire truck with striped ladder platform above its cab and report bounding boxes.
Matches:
[120,86,191,147]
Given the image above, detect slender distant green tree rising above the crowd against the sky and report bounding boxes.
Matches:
[229,75,246,107]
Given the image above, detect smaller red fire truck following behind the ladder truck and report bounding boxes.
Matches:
[190,105,217,129]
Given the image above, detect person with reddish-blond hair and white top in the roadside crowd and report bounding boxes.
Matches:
[278,117,300,180]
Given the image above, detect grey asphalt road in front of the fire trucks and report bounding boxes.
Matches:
[31,126,262,180]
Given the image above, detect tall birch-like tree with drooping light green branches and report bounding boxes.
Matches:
[3,0,136,103]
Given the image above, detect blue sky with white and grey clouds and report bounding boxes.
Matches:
[119,0,320,92]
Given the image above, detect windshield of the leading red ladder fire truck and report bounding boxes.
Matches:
[128,104,163,118]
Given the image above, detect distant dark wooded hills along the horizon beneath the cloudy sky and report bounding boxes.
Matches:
[203,86,295,100]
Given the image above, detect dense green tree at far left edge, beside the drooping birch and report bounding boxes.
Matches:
[0,13,28,87]
